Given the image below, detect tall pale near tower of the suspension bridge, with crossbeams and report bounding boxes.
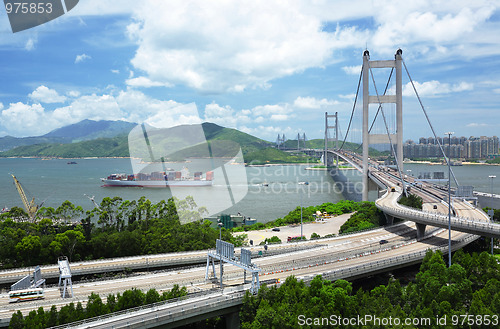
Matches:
[362,49,403,201]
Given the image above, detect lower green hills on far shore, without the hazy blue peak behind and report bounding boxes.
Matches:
[0,122,380,164]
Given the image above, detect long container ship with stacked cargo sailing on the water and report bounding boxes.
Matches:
[101,168,214,188]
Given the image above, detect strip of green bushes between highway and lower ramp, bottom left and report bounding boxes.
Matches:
[9,285,187,329]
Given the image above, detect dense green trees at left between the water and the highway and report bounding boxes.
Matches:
[0,197,236,269]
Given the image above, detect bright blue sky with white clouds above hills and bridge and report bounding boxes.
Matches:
[0,0,500,141]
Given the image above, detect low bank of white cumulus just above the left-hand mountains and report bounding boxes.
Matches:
[0,87,182,137]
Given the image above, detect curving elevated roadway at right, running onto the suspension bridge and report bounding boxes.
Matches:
[332,152,500,238]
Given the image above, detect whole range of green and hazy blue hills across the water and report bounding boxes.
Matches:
[0,120,380,163]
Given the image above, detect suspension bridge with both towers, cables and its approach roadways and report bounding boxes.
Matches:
[0,50,500,328]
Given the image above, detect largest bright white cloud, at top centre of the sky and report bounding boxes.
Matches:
[128,0,334,92]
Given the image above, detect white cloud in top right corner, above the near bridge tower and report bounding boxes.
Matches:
[367,0,498,58]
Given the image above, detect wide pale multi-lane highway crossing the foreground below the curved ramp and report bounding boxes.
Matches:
[0,213,477,323]
